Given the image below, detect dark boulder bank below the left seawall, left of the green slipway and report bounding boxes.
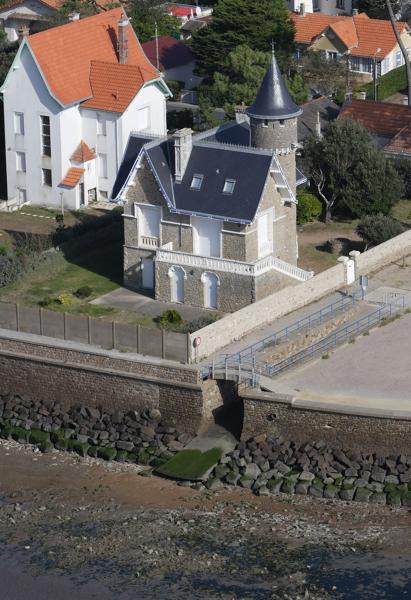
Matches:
[0,394,191,467]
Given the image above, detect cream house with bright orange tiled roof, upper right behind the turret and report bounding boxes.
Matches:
[292,13,411,80]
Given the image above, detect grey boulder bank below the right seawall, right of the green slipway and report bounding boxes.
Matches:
[202,435,411,507]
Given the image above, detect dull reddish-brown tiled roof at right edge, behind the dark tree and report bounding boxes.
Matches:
[338,100,411,137]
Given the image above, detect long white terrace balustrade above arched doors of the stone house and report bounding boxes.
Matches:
[156,248,314,281]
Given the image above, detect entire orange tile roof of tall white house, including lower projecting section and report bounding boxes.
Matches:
[26,8,159,112]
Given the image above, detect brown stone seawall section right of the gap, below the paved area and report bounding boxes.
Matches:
[241,392,411,455]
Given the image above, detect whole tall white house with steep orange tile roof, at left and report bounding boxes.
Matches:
[0,8,170,209]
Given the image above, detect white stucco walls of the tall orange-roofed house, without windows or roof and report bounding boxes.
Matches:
[3,41,166,209]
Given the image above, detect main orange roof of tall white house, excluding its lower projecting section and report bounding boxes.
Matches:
[27,8,159,110]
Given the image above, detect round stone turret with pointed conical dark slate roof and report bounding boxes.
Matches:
[246,49,302,193]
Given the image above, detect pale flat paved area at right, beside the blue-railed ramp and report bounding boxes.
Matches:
[275,314,411,414]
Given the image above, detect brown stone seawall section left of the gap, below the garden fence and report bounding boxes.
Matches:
[0,333,219,434]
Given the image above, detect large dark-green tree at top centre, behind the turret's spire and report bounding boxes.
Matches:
[192,0,294,78]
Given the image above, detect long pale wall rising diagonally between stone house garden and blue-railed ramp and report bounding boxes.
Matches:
[190,230,411,360]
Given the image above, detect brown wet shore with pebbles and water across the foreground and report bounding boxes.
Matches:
[0,441,411,600]
